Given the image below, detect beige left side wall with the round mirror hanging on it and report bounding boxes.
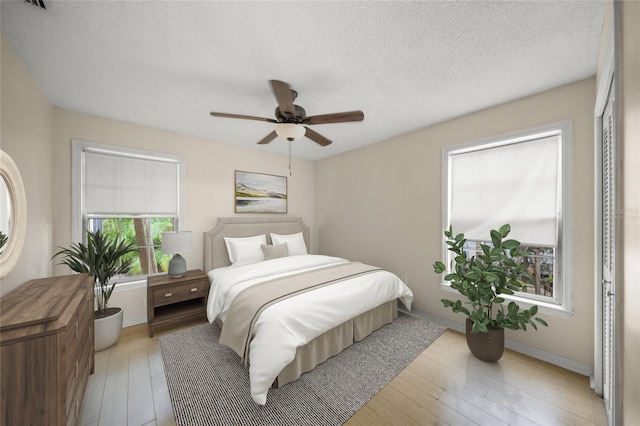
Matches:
[0,36,53,295]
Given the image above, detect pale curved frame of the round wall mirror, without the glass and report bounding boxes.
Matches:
[0,150,27,279]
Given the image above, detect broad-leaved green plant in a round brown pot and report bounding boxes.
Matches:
[433,224,548,362]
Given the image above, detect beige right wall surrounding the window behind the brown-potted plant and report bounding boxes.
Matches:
[316,78,596,366]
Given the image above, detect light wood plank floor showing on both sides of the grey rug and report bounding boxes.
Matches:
[79,323,607,426]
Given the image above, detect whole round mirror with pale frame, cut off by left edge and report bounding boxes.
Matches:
[0,150,27,278]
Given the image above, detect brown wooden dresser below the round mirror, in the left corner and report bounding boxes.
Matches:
[0,274,94,425]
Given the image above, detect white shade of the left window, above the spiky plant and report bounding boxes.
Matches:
[83,150,180,215]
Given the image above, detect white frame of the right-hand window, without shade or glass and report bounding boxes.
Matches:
[440,120,573,317]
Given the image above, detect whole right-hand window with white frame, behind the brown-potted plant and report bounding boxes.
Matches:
[443,121,571,312]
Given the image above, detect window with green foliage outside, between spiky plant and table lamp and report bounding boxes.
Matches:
[72,141,183,281]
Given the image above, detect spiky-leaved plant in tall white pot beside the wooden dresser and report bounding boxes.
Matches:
[53,230,135,351]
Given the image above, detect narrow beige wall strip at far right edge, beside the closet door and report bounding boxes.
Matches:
[616,1,640,425]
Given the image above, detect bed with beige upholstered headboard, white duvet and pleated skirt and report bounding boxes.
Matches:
[204,216,413,405]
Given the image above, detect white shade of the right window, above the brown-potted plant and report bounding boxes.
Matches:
[448,134,561,247]
